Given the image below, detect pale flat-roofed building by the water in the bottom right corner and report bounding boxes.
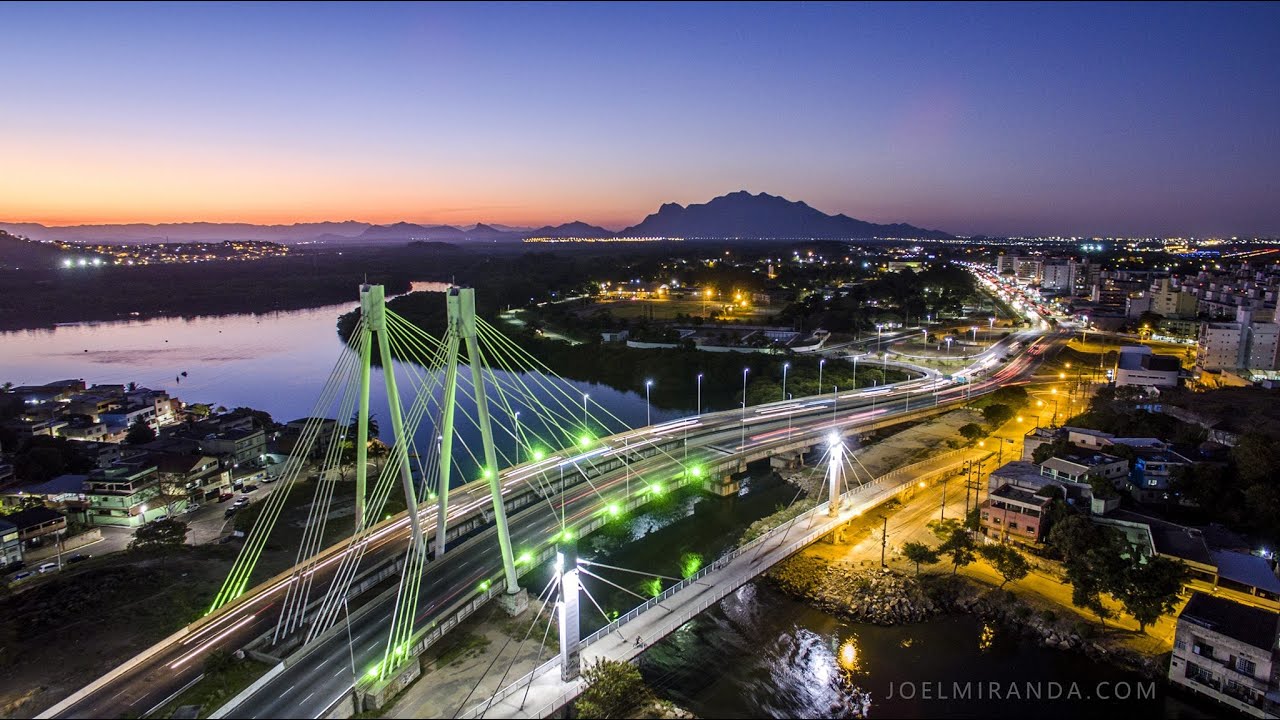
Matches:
[1169,592,1280,717]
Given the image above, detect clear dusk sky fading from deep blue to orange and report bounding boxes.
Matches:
[0,3,1280,236]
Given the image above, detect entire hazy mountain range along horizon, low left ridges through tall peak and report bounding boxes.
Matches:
[0,191,952,245]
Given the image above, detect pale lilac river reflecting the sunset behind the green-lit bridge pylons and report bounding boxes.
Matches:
[0,289,680,484]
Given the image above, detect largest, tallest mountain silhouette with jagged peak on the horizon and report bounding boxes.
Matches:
[618,190,952,240]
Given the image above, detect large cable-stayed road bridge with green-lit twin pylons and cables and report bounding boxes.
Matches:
[42,286,1054,717]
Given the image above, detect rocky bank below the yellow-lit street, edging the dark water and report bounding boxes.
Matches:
[765,555,1164,678]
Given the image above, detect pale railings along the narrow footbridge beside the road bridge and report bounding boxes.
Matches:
[458,448,965,717]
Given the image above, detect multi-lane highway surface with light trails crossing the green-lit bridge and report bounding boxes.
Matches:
[42,324,1054,717]
